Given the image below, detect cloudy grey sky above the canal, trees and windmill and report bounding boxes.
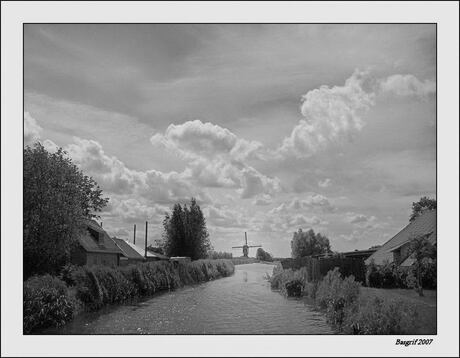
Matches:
[24,24,436,257]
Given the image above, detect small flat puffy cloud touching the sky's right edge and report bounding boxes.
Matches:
[379,74,436,98]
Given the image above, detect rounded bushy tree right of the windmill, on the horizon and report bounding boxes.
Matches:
[291,229,331,259]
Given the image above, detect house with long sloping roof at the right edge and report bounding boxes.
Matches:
[365,210,436,266]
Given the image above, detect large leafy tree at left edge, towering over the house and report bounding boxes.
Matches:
[23,143,108,278]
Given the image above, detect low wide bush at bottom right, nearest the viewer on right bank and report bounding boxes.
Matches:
[343,297,417,334]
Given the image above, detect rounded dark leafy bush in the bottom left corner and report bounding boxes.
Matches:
[23,275,76,333]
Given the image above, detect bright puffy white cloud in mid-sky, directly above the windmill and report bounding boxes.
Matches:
[150,120,281,199]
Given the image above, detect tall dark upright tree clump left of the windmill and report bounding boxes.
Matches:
[163,198,212,260]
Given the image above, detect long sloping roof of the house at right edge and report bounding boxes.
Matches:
[365,210,436,265]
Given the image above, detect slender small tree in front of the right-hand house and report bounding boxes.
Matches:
[409,234,437,296]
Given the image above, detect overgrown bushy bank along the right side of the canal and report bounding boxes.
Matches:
[270,267,436,334]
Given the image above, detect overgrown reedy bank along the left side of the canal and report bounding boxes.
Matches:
[23,260,235,334]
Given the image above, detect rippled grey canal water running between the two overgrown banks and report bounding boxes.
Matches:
[43,264,334,334]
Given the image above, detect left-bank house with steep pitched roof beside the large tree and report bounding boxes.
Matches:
[71,220,124,267]
